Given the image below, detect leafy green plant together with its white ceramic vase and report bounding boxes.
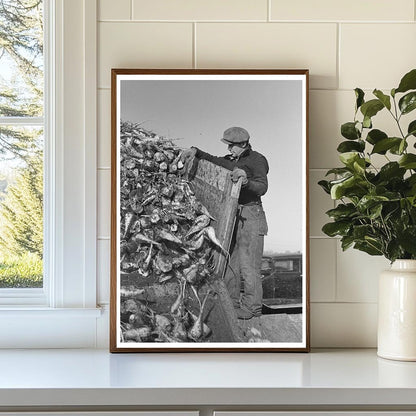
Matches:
[319,69,416,361]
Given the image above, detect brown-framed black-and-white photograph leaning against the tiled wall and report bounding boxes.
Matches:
[110,69,309,352]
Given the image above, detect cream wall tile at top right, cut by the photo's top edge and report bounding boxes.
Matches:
[271,0,414,21]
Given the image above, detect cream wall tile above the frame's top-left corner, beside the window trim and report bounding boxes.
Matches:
[98,22,193,88]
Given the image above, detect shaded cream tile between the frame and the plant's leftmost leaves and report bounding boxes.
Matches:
[309,170,335,237]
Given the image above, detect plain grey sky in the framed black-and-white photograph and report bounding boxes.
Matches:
[120,80,304,253]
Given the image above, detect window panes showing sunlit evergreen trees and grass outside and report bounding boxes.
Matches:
[0,0,45,289]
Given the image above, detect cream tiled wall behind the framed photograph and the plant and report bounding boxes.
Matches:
[97,0,416,347]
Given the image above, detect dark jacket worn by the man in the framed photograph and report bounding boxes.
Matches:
[195,146,269,205]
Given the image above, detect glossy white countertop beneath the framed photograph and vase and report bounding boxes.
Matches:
[0,349,416,409]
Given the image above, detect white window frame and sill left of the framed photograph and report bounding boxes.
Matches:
[0,0,100,348]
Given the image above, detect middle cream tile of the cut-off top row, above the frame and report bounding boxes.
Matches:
[133,0,267,20]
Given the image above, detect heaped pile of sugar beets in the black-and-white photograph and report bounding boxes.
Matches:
[120,122,224,342]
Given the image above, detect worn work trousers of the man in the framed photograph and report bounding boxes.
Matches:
[224,204,267,316]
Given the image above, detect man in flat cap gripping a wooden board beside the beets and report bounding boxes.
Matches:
[182,127,269,320]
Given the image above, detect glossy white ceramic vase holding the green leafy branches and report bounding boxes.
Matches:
[377,260,416,361]
